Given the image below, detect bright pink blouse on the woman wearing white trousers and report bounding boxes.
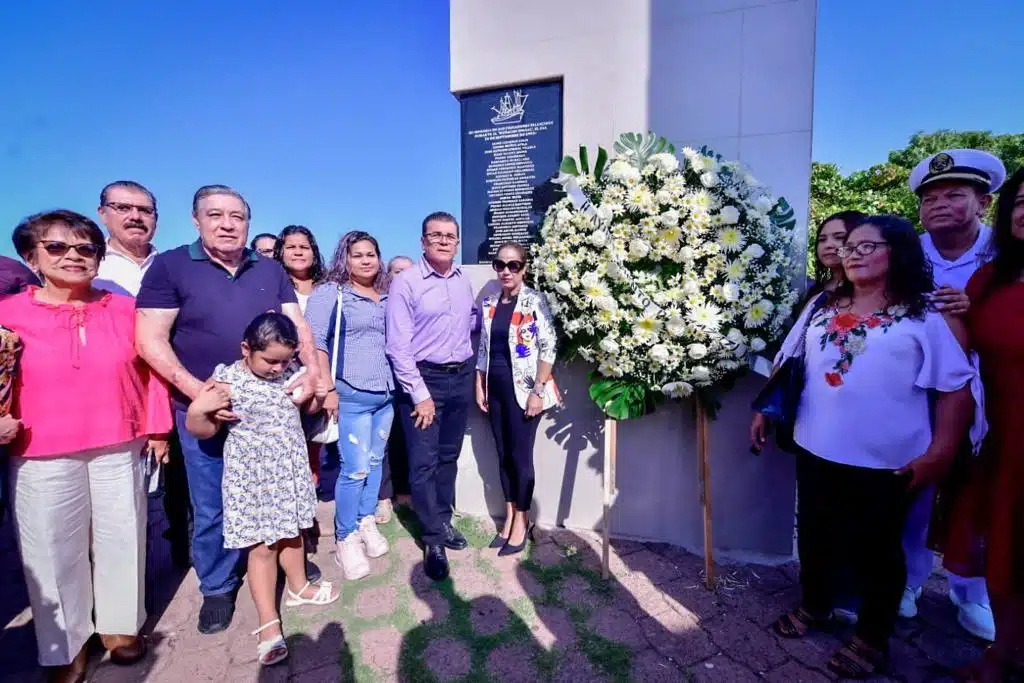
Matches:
[0,287,173,458]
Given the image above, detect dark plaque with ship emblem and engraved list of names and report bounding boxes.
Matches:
[459,82,562,263]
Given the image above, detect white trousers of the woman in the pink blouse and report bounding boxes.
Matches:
[10,439,146,667]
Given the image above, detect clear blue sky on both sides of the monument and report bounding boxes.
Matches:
[0,0,1024,256]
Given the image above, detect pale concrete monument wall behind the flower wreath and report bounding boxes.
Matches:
[451,0,816,558]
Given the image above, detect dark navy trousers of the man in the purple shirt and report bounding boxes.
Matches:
[398,358,476,546]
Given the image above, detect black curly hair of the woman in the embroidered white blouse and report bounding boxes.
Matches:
[831,216,935,317]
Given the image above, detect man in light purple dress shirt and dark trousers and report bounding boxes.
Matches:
[387,212,477,581]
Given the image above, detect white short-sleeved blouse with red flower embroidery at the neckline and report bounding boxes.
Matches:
[783,306,977,469]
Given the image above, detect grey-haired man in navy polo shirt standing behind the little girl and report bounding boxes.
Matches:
[135,185,326,633]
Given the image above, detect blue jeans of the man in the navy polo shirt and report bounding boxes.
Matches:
[174,410,244,596]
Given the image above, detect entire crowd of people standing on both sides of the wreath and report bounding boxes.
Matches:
[0,144,1024,683]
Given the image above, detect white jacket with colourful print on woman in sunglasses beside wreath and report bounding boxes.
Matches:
[476,287,561,410]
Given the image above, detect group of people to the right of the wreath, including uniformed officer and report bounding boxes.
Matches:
[751,150,1024,683]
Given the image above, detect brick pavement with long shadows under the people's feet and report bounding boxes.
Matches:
[0,497,982,683]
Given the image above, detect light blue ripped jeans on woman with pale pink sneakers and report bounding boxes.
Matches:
[334,380,394,541]
